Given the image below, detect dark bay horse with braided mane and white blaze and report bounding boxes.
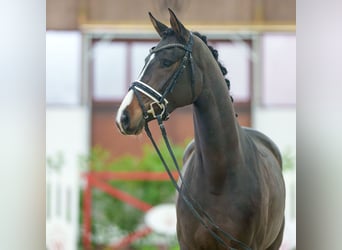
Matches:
[116,10,285,250]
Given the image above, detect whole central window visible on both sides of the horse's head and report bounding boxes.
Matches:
[92,37,251,103]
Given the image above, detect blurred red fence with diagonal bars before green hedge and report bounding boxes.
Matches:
[83,172,178,250]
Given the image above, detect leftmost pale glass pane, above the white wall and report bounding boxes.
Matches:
[46,31,81,104]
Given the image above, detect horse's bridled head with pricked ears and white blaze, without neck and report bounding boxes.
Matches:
[116,10,201,134]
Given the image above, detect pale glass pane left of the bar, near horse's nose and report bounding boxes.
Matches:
[93,41,128,101]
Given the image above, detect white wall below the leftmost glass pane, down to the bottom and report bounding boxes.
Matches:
[46,106,89,250]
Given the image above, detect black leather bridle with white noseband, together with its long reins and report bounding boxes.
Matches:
[129,33,252,250]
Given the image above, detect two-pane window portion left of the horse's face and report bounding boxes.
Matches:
[93,40,157,102]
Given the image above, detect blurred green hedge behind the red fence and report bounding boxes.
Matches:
[80,143,186,249]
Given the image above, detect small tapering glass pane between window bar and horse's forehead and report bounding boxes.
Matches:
[130,42,157,82]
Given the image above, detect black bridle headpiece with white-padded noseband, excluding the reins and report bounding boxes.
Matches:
[129,33,194,122]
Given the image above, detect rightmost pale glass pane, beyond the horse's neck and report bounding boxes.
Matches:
[262,34,296,105]
